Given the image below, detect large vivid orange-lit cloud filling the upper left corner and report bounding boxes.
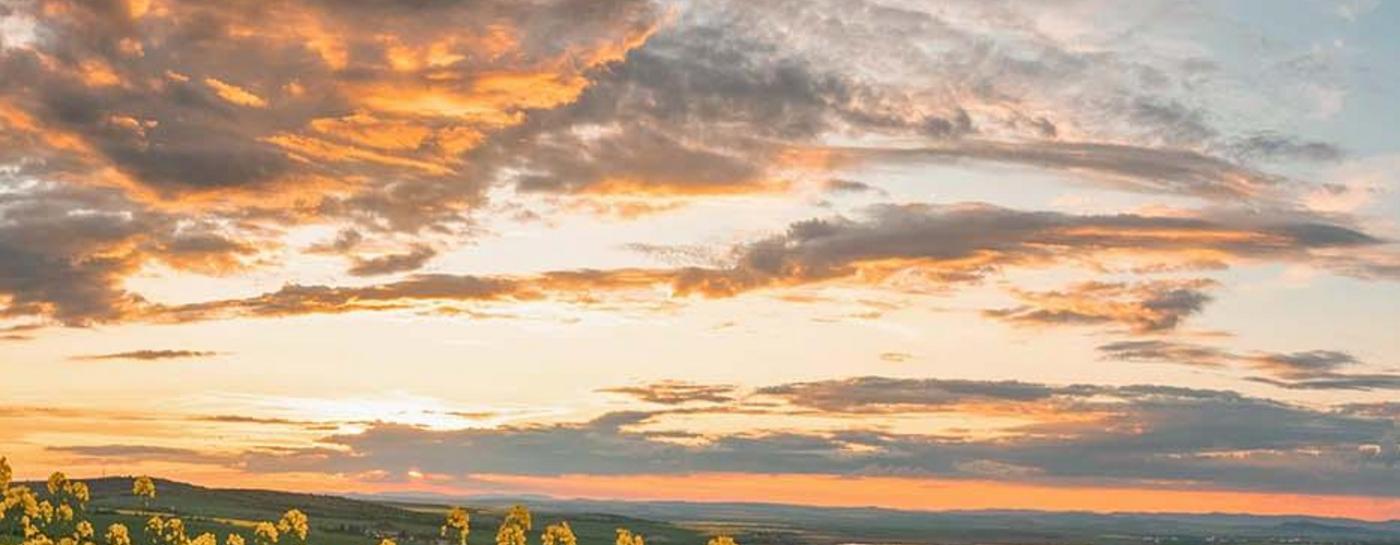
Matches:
[0,0,659,204]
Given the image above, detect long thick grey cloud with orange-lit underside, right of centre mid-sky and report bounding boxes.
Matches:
[679,203,1380,293]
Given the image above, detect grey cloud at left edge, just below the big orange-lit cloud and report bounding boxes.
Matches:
[0,180,281,326]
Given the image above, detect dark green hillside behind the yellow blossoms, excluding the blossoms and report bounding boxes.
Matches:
[0,478,708,545]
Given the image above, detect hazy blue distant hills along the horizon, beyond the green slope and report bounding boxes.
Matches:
[355,487,1400,544]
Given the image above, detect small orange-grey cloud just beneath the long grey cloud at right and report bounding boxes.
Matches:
[983,279,1217,335]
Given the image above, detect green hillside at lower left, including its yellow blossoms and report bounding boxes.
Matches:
[0,458,736,545]
